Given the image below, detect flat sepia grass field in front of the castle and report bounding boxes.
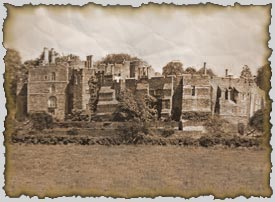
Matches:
[4,144,271,198]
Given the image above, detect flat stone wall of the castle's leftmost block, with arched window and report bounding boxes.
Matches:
[27,65,68,119]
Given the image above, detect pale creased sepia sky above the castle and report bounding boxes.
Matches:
[4,4,270,75]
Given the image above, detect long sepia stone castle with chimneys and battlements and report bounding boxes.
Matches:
[22,48,265,127]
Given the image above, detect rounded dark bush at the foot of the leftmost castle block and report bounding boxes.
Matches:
[30,112,53,131]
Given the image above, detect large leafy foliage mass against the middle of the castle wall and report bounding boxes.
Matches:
[114,89,157,121]
